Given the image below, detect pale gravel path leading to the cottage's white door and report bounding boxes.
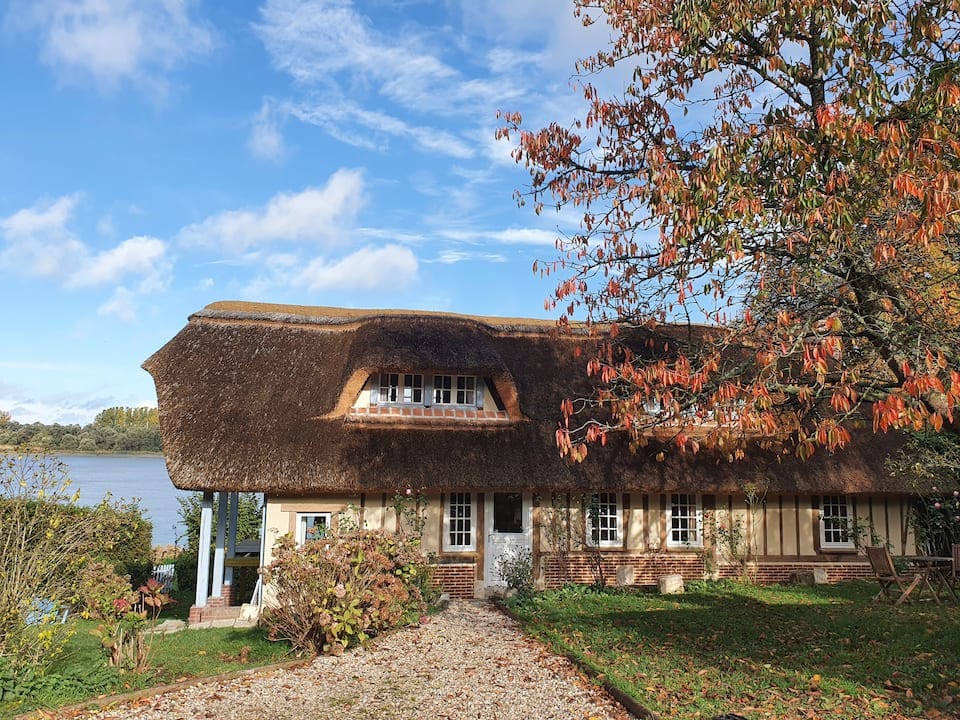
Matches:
[77,602,630,720]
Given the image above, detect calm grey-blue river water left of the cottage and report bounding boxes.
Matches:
[59,455,190,545]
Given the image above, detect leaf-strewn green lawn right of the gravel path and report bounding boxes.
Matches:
[511,582,960,720]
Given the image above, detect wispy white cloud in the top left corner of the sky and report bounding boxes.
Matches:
[7,0,216,92]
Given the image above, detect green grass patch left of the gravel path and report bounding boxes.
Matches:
[0,618,292,718]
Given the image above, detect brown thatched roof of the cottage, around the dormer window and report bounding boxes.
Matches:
[144,302,908,494]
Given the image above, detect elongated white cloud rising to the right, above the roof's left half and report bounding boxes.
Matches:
[178,170,365,255]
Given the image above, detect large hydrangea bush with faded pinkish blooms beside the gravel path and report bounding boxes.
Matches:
[263,532,428,655]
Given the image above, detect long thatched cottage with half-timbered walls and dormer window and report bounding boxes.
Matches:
[144,302,914,617]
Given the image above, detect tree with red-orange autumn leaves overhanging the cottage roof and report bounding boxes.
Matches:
[499,0,960,458]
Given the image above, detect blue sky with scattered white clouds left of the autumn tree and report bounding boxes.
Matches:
[0,0,606,423]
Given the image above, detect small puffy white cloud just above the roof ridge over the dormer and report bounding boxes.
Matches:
[292,245,418,291]
